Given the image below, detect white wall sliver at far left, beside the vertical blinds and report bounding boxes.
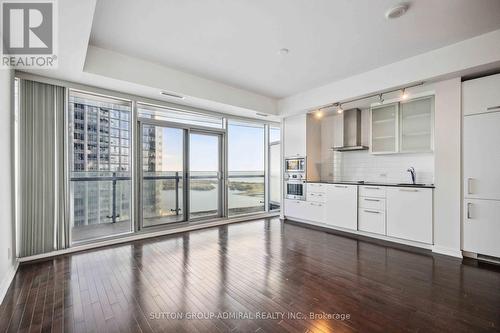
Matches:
[0,69,16,301]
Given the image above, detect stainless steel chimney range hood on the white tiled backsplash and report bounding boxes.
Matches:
[332,109,368,151]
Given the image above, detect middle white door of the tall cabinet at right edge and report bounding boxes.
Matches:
[463,111,500,200]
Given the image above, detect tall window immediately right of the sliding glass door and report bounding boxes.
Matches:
[227,121,265,216]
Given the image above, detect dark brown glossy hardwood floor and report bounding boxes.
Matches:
[0,219,500,332]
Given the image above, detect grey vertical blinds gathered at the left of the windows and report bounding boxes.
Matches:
[19,80,69,257]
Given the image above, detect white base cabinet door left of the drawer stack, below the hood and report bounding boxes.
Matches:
[325,184,358,230]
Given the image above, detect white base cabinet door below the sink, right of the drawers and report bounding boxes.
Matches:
[386,187,433,244]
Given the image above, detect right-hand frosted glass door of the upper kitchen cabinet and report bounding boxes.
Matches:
[399,96,434,153]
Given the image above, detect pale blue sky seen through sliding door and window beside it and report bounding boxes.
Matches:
[158,124,264,172]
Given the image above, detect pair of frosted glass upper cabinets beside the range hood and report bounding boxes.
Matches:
[371,96,434,154]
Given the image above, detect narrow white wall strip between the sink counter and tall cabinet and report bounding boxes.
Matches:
[434,78,462,256]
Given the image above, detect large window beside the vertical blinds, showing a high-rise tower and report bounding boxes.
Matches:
[69,91,132,243]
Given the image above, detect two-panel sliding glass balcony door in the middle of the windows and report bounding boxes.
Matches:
[139,119,223,228]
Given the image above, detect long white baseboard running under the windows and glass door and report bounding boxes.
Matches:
[18,212,279,263]
